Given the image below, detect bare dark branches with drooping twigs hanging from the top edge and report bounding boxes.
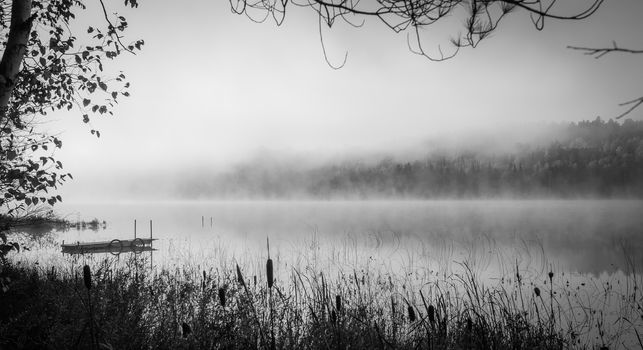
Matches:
[234,0,604,65]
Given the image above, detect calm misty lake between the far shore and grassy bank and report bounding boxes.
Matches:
[12,200,643,347]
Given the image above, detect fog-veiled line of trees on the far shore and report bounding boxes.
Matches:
[182,118,643,199]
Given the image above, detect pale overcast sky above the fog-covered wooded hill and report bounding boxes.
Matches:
[48,0,643,199]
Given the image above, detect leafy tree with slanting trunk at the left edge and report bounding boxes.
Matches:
[0,0,143,214]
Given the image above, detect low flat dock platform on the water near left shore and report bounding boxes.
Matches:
[60,238,157,255]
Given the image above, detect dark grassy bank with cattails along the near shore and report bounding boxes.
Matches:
[0,255,643,349]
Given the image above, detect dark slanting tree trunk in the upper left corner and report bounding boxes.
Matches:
[0,0,34,118]
